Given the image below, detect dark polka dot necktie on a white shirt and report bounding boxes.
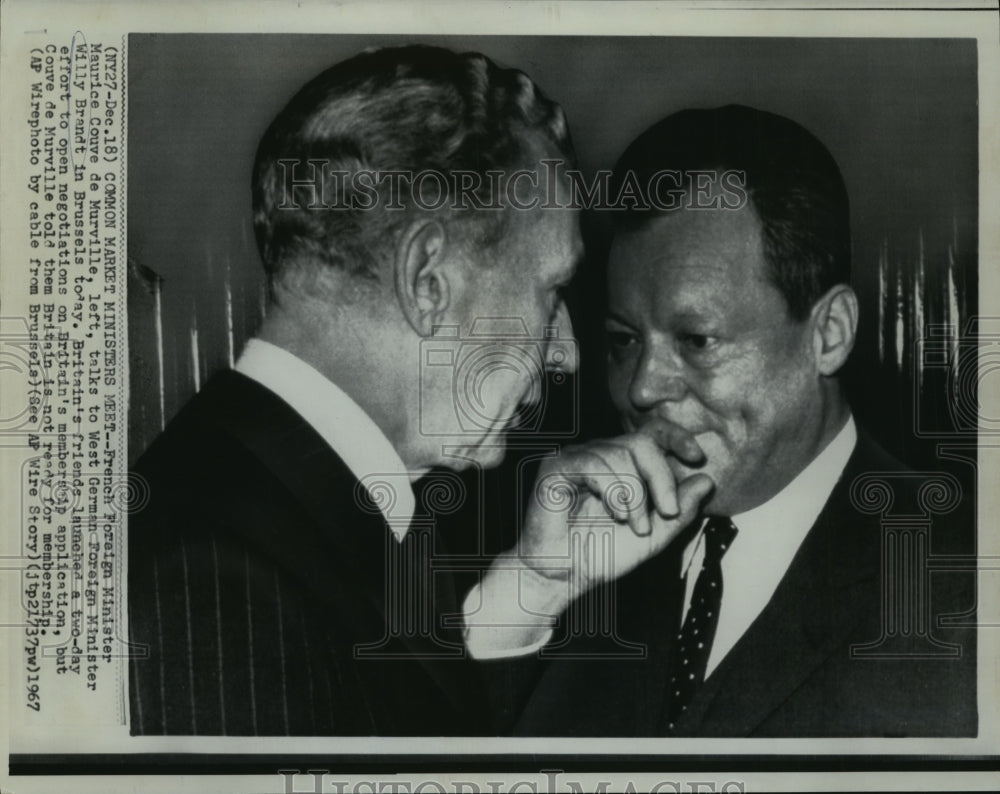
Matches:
[667,517,737,730]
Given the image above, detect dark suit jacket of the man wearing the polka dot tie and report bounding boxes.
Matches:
[506,426,977,737]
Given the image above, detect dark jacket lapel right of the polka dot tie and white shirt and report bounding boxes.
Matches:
[677,442,879,736]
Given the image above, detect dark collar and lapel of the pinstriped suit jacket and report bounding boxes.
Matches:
[194,371,480,709]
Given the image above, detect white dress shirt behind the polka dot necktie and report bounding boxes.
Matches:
[681,417,858,678]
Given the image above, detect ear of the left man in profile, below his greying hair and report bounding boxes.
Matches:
[393,220,452,336]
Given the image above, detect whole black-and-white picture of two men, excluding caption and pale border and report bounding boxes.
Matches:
[127,33,976,738]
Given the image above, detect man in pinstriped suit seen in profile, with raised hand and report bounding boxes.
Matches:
[128,47,710,735]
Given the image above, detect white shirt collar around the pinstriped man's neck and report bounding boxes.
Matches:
[235,339,416,541]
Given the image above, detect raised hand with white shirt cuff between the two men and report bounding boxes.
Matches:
[466,419,714,656]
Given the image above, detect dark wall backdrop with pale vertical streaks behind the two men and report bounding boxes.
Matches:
[128,35,978,545]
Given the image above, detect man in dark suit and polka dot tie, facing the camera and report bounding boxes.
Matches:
[517,106,977,736]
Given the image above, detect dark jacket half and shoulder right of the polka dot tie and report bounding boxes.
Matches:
[679,432,976,737]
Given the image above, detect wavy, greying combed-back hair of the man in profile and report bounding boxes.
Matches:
[253,45,573,296]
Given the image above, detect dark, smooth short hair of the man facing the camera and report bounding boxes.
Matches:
[612,105,851,321]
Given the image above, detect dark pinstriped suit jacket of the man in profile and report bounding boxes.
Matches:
[128,372,485,735]
